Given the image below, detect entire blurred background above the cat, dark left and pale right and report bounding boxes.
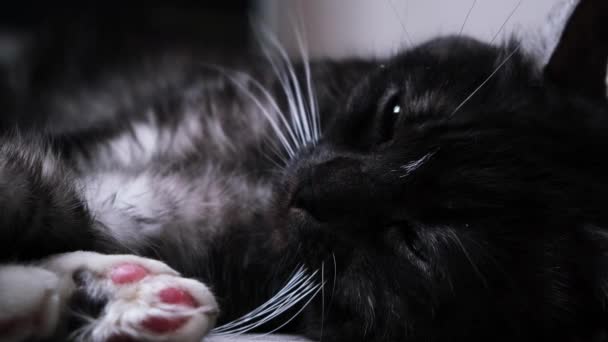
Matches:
[0,0,557,116]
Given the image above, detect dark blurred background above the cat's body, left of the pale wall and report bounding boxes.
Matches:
[0,0,254,117]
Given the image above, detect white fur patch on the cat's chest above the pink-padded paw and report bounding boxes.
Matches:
[81,166,262,246]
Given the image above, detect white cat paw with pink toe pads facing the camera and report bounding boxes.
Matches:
[45,252,219,342]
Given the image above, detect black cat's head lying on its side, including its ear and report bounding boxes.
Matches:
[279,0,608,341]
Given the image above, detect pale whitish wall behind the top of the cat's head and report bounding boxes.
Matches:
[260,0,558,57]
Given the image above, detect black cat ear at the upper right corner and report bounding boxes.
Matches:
[544,0,608,98]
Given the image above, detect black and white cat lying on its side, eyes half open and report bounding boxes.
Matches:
[0,0,608,341]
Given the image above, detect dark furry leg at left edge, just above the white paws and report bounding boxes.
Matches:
[0,136,104,264]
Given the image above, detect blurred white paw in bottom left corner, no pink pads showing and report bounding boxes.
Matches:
[0,265,61,342]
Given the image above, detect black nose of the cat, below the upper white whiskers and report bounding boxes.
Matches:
[291,157,366,221]
